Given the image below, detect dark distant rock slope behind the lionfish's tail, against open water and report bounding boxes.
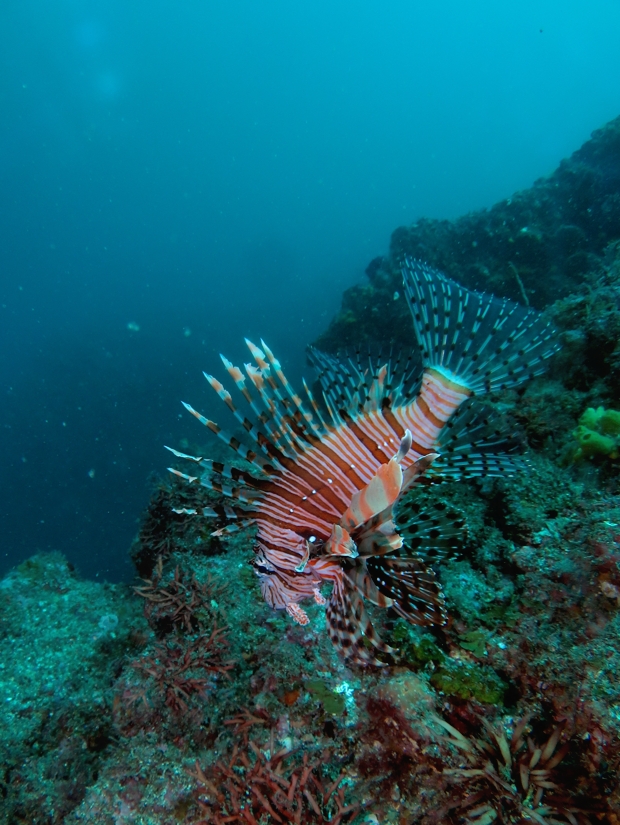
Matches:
[315,112,620,352]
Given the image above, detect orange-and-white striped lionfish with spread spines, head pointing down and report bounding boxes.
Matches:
[168,259,558,665]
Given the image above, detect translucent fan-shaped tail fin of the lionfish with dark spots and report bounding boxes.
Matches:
[402,258,559,395]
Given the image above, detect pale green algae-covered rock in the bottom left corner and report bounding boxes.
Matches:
[0,554,144,825]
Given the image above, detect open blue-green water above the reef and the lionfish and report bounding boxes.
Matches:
[0,0,620,579]
